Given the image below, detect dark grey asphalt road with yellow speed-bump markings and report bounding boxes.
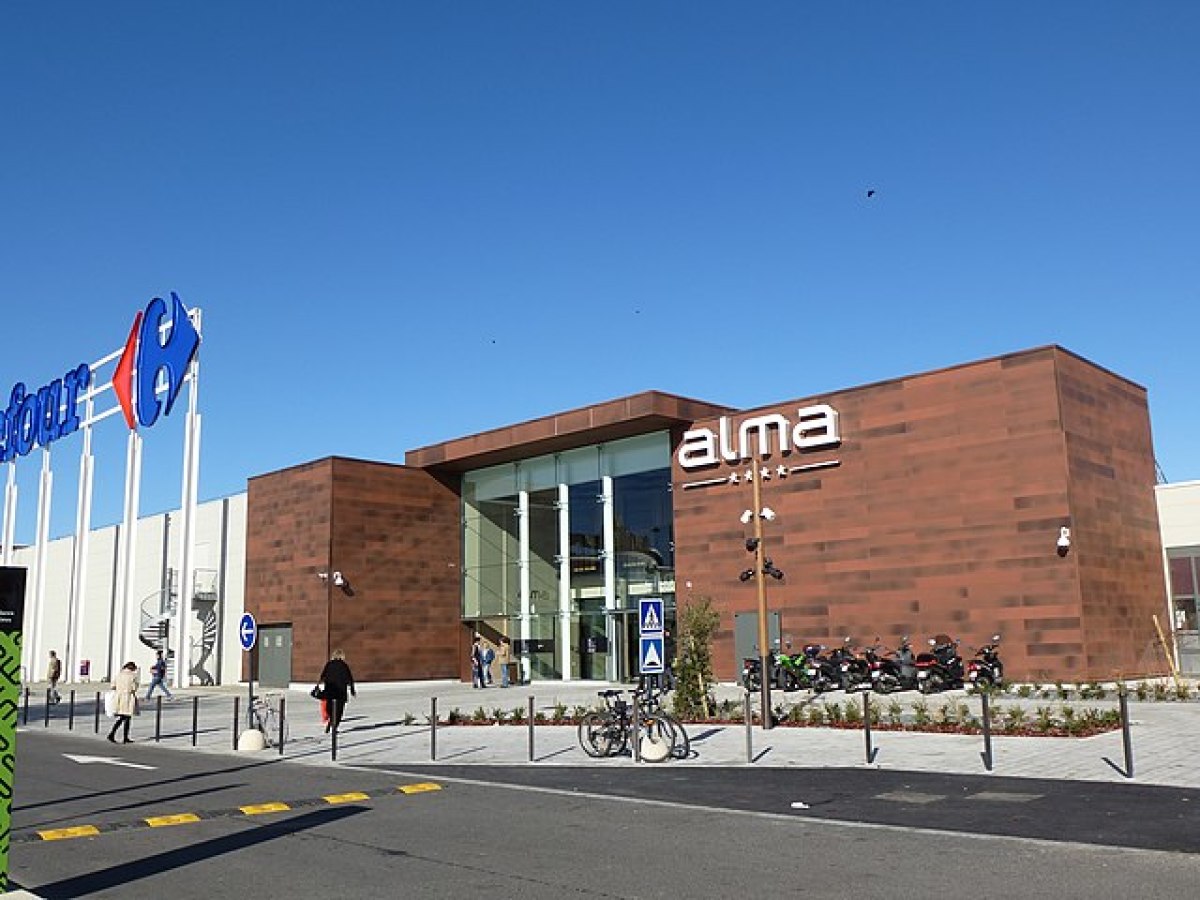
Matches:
[10,731,1200,900]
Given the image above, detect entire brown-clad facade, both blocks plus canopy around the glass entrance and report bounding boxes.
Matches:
[246,347,1165,682]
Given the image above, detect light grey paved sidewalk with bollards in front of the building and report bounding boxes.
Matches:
[23,682,1200,787]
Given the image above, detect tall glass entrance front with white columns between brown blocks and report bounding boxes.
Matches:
[462,432,674,680]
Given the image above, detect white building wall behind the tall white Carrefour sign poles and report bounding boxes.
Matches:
[13,493,246,684]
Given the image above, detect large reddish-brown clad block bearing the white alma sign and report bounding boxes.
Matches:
[673,347,1165,680]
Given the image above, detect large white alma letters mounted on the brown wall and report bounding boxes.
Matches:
[676,403,841,469]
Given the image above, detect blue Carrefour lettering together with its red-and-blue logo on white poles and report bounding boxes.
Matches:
[0,293,200,462]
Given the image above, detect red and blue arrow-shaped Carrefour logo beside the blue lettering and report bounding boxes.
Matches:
[113,292,200,428]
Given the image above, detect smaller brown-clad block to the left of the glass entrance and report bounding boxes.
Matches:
[246,457,462,682]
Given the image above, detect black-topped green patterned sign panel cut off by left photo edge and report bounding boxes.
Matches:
[0,566,25,892]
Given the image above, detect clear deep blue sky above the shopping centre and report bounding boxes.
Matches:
[0,0,1200,540]
